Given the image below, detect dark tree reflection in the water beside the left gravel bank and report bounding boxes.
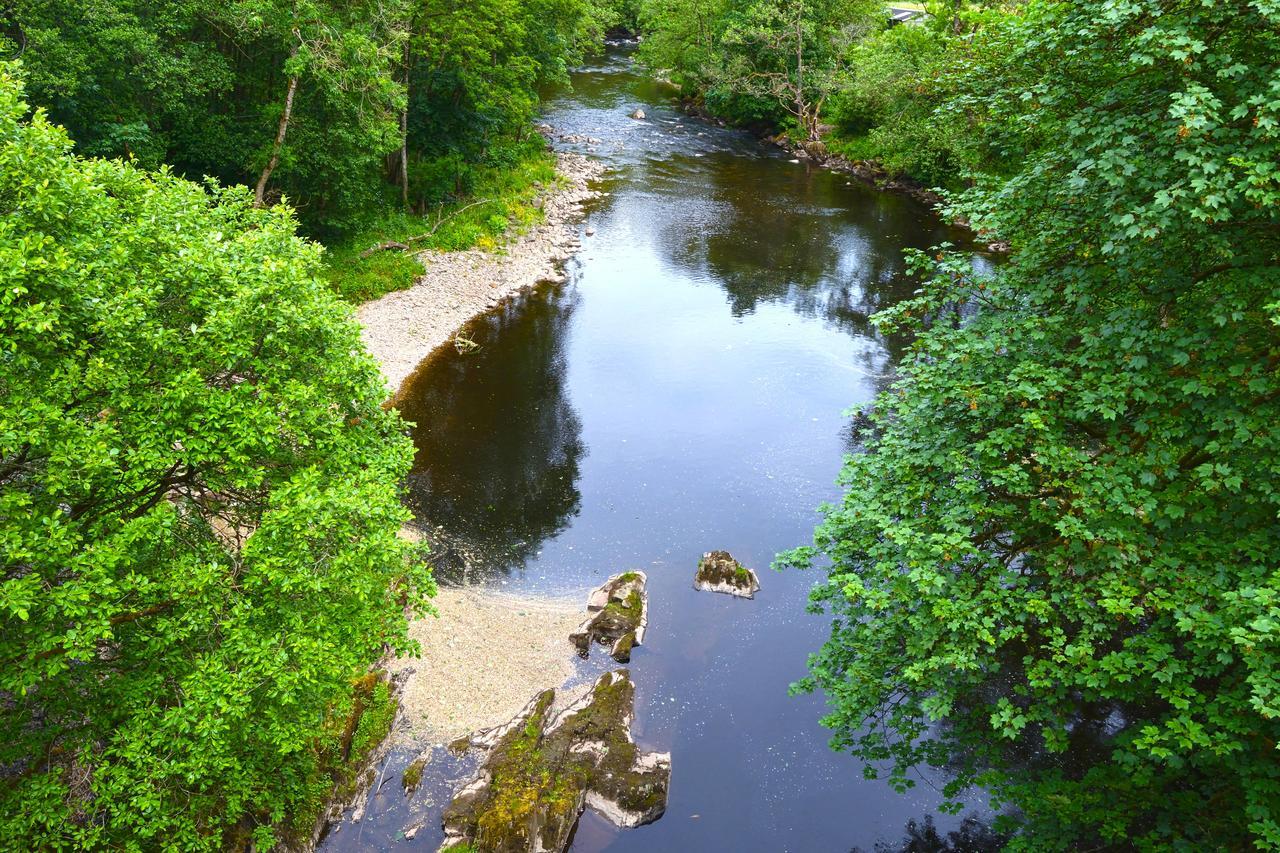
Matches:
[398,286,586,580]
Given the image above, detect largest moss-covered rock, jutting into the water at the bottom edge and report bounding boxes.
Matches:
[440,670,671,853]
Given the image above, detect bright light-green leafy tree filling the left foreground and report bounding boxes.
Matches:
[0,67,433,849]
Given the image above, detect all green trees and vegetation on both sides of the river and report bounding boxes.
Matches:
[0,0,1280,849]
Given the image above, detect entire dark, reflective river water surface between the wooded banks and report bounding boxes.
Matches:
[324,51,980,853]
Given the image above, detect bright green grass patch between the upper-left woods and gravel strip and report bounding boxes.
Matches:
[324,149,557,305]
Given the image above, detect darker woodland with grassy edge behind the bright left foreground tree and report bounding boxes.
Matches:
[8,0,630,298]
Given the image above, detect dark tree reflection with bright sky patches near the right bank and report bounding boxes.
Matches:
[643,152,948,389]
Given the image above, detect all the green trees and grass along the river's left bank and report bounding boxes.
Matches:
[0,0,624,849]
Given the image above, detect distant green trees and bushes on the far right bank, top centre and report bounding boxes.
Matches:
[637,0,1027,188]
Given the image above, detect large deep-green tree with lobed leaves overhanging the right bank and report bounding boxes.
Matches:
[785,0,1280,849]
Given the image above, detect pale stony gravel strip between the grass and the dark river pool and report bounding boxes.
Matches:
[356,154,604,394]
